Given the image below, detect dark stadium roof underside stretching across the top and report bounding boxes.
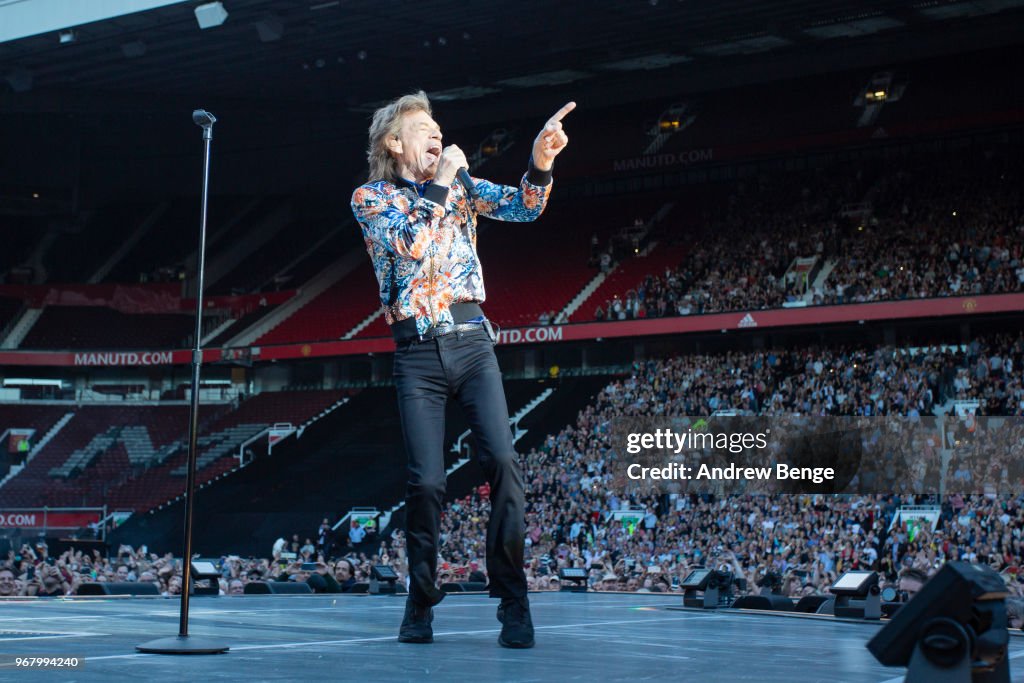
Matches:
[0,0,1024,120]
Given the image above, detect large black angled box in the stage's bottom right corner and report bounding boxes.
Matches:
[867,562,1010,683]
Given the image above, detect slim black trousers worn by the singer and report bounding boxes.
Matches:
[394,328,526,605]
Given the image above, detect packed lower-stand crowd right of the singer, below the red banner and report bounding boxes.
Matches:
[458,335,1024,595]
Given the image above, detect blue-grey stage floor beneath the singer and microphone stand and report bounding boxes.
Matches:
[0,593,1024,683]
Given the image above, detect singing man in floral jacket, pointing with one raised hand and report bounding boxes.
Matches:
[352,91,575,647]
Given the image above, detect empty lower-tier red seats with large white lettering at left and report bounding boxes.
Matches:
[0,391,343,509]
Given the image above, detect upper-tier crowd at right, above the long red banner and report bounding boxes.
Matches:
[594,146,1024,319]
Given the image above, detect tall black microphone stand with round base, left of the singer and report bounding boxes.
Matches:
[135,110,228,654]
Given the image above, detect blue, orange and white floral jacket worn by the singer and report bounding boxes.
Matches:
[352,168,551,334]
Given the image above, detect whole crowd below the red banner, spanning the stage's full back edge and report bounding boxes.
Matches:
[8,333,1024,610]
